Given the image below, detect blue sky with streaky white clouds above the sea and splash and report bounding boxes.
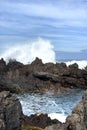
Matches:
[0,0,87,62]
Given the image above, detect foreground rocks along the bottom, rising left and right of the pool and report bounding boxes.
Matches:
[0,91,87,130]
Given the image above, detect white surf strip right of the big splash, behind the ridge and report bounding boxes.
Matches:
[65,60,87,69]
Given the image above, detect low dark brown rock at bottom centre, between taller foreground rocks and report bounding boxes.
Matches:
[22,113,59,128]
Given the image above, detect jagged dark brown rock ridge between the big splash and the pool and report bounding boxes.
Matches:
[0,58,87,93]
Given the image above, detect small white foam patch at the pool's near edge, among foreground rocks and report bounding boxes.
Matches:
[48,113,67,123]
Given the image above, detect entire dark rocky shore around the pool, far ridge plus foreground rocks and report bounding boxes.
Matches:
[0,58,87,130]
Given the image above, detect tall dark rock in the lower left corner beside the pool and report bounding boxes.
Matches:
[0,91,22,130]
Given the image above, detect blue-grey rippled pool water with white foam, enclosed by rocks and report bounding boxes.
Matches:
[17,89,83,122]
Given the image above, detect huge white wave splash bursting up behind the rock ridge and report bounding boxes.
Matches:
[0,38,55,64]
